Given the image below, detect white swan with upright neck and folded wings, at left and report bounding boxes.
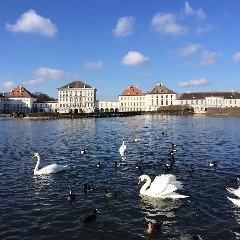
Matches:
[32,153,68,175]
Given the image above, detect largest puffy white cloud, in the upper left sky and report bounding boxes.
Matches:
[6,9,57,37]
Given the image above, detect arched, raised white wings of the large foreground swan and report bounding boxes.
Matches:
[148,174,182,195]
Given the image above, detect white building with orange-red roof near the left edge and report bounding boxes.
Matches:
[2,86,36,114]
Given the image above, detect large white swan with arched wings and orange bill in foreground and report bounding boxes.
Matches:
[138,174,188,198]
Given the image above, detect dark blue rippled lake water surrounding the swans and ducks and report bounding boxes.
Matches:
[0,115,240,240]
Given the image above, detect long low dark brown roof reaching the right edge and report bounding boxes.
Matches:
[178,92,240,100]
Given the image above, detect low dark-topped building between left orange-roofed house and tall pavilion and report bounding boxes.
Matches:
[33,93,58,113]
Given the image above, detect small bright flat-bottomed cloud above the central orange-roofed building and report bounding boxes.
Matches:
[122,51,149,66]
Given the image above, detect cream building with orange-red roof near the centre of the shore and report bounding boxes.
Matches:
[118,85,145,112]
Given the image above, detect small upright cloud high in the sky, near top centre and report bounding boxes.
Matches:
[113,17,135,37]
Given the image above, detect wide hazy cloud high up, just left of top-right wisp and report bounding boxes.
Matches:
[151,13,187,35]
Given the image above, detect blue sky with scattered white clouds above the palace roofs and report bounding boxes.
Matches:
[0,0,240,99]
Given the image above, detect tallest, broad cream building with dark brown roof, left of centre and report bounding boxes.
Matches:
[58,81,97,113]
